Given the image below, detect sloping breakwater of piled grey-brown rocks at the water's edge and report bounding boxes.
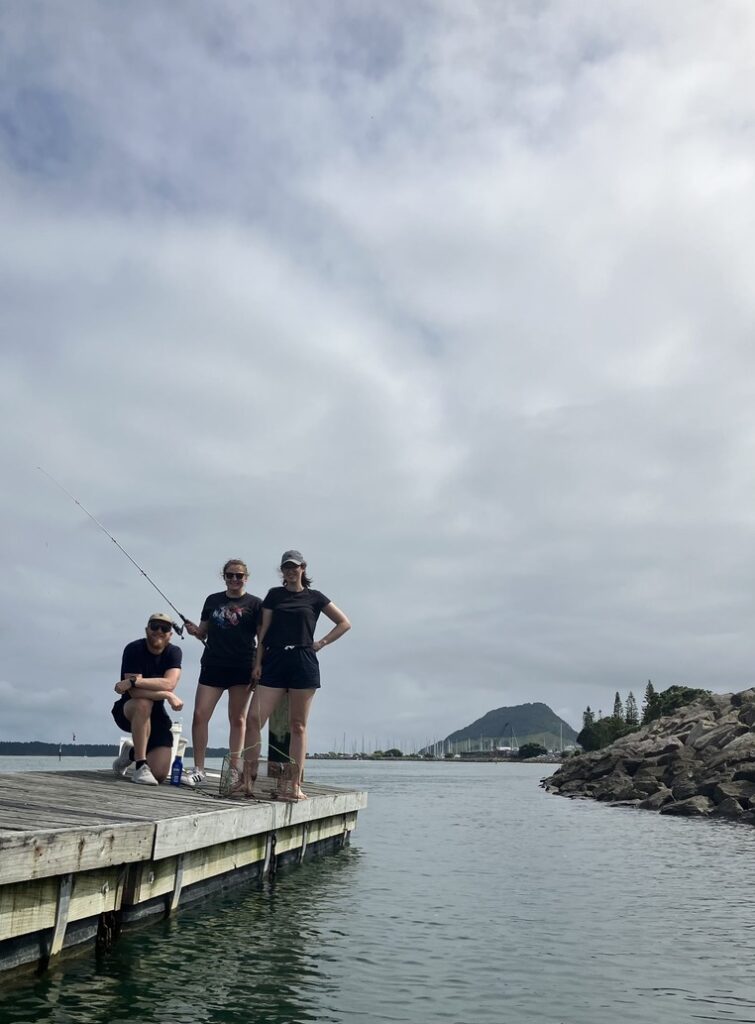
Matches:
[542,688,755,824]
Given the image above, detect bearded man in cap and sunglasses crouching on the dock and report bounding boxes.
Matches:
[113,611,183,785]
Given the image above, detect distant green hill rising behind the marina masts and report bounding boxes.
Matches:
[445,703,577,750]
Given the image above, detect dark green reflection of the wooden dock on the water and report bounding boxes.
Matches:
[0,850,361,1024]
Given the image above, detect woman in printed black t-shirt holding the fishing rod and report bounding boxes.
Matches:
[186,558,262,785]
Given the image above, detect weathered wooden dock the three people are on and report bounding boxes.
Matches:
[0,771,367,972]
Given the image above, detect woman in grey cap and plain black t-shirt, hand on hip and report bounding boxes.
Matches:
[241,550,351,800]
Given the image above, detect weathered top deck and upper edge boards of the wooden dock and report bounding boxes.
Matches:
[0,771,366,885]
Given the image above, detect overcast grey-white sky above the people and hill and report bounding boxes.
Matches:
[0,0,755,750]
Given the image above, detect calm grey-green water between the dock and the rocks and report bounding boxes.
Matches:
[0,758,755,1024]
